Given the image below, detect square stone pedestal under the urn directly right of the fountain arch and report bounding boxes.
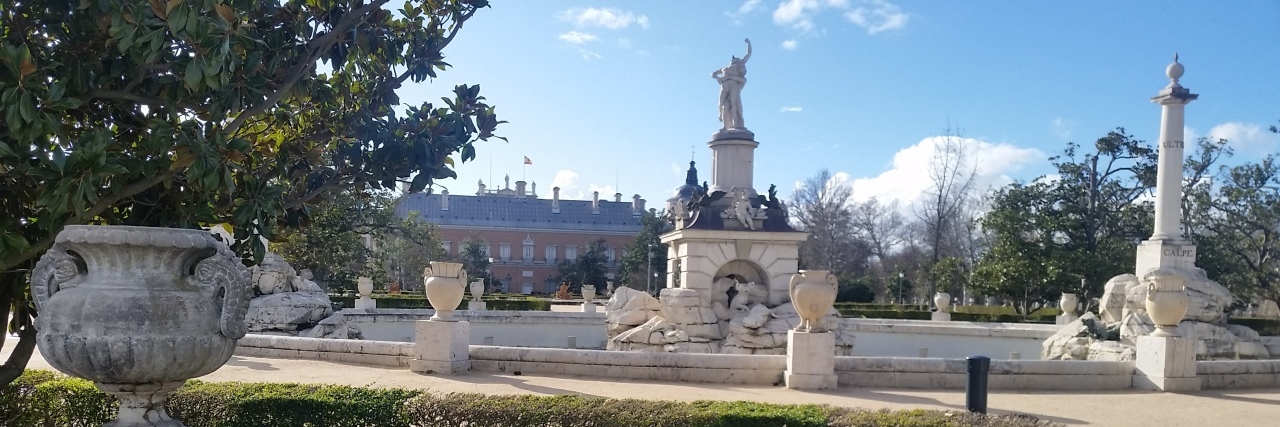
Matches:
[783,330,836,390]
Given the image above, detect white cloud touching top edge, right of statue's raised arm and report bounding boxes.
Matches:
[768,0,910,35]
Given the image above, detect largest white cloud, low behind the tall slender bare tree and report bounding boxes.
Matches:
[852,137,1046,207]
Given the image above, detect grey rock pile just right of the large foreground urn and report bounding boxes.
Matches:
[244,252,361,339]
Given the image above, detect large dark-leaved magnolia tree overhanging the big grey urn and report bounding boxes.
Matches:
[0,0,500,385]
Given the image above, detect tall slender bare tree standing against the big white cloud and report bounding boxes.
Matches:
[915,128,978,301]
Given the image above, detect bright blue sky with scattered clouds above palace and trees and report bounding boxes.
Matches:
[403,0,1280,207]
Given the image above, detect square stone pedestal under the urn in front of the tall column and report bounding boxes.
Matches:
[1133,336,1201,391]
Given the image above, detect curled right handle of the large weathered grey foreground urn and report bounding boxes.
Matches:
[195,245,252,340]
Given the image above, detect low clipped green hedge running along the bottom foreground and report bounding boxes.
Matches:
[0,371,1060,427]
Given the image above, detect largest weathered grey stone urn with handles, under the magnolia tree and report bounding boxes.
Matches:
[31,225,253,427]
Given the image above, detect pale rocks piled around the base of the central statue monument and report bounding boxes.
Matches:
[607,279,854,355]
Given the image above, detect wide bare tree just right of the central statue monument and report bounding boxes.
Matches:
[791,169,870,275]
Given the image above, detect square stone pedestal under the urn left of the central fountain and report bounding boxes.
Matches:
[408,321,471,373]
